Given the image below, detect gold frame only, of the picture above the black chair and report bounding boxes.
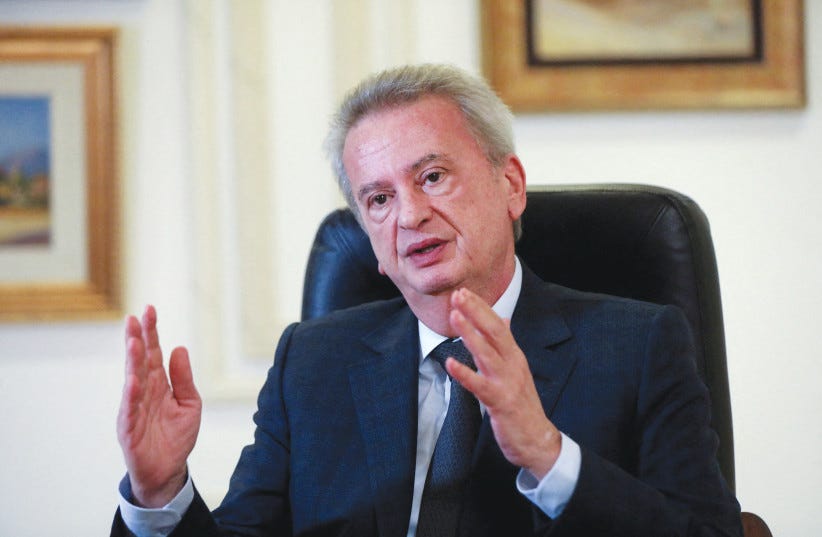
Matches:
[482,0,805,112]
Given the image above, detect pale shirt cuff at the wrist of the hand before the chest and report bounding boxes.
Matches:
[517,433,582,519]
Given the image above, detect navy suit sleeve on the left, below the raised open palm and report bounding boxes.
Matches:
[111,324,297,537]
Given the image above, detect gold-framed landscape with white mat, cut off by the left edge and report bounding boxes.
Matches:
[0,27,120,320]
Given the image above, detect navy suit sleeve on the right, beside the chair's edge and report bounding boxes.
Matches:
[543,307,742,537]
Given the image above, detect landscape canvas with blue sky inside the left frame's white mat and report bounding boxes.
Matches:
[0,96,51,248]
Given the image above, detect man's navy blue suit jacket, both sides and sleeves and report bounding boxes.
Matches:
[112,268,742,537]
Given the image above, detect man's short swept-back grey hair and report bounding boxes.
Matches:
[325,64,521,238]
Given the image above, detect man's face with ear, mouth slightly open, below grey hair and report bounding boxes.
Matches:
[343,97,525,302]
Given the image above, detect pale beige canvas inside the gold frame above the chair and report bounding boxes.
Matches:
[529,0,761,64]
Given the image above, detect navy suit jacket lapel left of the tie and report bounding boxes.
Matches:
[348,307,419,537]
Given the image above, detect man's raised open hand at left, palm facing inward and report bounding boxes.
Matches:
[117,306,202,508]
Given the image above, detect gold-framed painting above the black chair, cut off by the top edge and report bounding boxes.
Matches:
[482,0,805,111]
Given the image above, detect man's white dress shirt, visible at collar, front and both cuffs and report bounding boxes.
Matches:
[120,259,581,537]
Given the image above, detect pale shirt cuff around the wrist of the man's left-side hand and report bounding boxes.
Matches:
[119,474,194,537]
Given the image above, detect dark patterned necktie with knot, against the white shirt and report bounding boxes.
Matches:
[416,339,482,537]
